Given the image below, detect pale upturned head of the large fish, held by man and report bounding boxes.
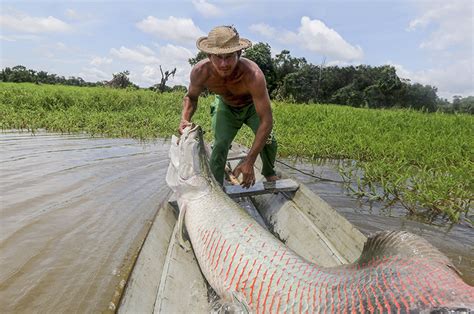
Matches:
[166,124,213,198]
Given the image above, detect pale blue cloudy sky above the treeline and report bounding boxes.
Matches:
[0,0,474,101]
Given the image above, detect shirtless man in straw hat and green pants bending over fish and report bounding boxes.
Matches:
[179,26,278,188]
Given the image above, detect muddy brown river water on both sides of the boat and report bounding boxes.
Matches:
[0,131,474,313]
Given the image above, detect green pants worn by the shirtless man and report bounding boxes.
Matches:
[210,96,277,184]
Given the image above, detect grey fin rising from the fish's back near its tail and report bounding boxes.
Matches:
[357,231,455,269]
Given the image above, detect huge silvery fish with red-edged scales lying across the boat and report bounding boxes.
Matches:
[166,126,474,313]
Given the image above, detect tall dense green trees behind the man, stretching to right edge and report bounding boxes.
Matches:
[189,43,474,114]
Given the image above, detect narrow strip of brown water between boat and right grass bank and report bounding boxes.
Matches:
[277,160,474,286]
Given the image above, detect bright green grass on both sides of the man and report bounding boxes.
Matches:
[0,83,474,224]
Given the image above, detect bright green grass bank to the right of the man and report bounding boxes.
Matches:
[268,103,474,224]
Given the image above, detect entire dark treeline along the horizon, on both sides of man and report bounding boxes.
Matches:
[0,43,474,114]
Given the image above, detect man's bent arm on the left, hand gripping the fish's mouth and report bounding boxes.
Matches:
[178,64,203,134]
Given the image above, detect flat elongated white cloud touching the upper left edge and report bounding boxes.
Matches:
[0,14,72,33]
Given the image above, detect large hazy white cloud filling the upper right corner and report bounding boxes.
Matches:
[397,0,474,99]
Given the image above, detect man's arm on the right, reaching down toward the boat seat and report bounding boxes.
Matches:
[234,70,273,188]
